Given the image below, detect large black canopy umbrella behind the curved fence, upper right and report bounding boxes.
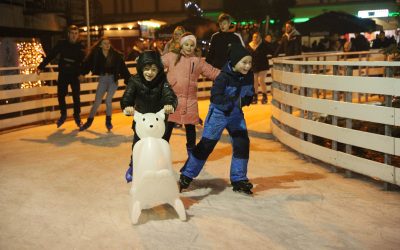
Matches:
[296,11,382,35]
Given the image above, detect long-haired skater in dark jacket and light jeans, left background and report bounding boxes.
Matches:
[80,37,131,131]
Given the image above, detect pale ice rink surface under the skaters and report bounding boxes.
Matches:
[0,101,400,250]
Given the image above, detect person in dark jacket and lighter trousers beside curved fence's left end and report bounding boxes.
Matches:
[249,32,273,104]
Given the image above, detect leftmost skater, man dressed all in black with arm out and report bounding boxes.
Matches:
[37,25,85,128]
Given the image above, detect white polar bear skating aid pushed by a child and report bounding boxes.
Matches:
[130,110,186,224]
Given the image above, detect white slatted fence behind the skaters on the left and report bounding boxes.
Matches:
[0,62,216,130]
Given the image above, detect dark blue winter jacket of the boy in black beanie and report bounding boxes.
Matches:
[211,62,254,114]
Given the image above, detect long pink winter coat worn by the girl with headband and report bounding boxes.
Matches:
[162,52,220,124]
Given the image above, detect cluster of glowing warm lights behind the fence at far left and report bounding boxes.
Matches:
[17,39,44,89]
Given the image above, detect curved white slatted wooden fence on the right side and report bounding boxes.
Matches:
[271,52,400,185]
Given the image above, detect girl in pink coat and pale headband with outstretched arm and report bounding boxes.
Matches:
[162,32,220,155]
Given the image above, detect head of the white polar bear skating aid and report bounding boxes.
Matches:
[134,109,165,139]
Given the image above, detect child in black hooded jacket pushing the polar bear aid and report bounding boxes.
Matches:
[121,50,178,182]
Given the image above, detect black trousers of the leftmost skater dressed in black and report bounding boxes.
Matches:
[57,73,81,116]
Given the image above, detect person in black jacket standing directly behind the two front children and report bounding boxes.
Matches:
[206,13,245,69]
